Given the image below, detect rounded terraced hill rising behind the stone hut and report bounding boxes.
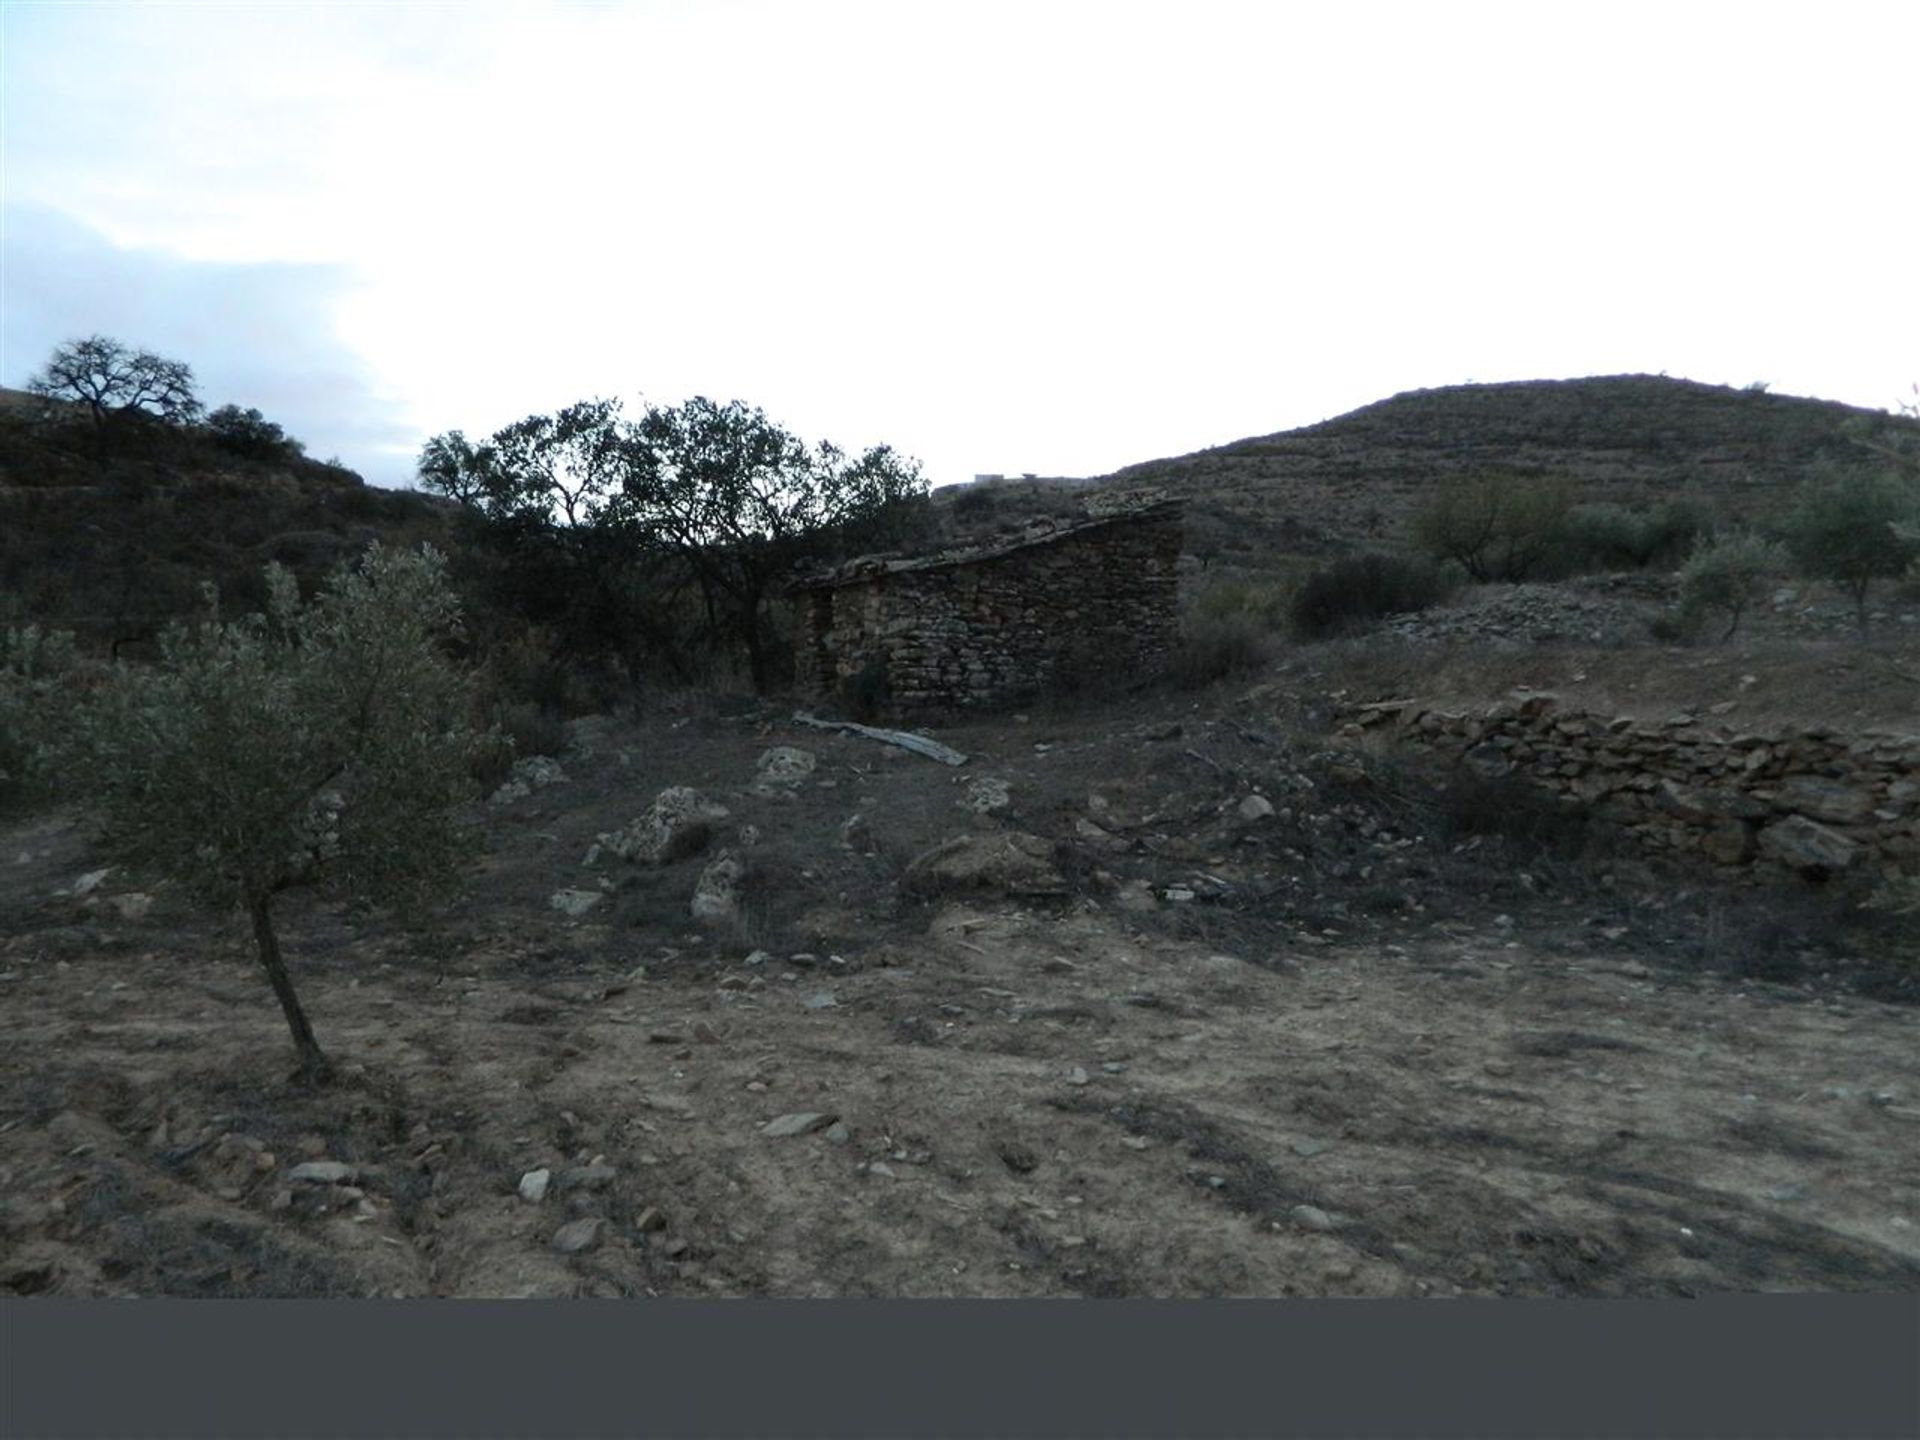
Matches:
[1104,374,1920,553]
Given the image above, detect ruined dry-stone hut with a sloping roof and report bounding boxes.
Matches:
[789,497,1181,712]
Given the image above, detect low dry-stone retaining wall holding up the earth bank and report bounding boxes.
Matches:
[1344,693,1920,881]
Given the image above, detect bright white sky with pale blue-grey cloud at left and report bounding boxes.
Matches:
[0,0,1920,484]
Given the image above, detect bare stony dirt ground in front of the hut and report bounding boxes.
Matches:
[0,687,1920,1296]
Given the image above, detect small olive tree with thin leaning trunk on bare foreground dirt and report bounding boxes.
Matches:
[63,547,482,1081]
